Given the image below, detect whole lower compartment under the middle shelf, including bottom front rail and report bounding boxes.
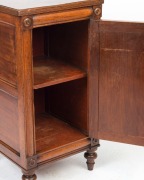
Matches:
[34,78,90,157]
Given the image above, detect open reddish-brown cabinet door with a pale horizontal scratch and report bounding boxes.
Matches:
[98,21,144,145]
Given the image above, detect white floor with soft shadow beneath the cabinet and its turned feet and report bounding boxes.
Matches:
[0,141,144,180]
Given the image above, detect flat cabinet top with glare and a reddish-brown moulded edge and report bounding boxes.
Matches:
[0,0,104,16]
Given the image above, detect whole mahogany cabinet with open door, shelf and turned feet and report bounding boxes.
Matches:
[0,0,144,180]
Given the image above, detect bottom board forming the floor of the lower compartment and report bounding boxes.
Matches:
[36,113,88,153]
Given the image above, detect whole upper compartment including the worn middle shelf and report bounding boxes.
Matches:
[32,20,89,89]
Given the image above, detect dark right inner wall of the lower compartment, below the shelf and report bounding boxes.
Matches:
[47,79,88,133]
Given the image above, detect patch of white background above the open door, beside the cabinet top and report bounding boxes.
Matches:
[103,0,144,22]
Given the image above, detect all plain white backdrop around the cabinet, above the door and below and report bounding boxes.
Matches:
[0,0,144,180]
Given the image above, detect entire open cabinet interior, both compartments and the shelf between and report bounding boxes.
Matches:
[32,20,88,152]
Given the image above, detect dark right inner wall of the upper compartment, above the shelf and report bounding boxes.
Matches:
[49,21,88,70]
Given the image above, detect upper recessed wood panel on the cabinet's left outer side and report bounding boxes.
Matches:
[0,20,16,86]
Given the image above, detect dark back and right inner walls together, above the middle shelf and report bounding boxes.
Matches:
[33,21,89,71]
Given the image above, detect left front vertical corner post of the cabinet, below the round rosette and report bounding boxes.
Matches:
[17,27,36,169]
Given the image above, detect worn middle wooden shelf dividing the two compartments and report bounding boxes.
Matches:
[34,57,86,89]
